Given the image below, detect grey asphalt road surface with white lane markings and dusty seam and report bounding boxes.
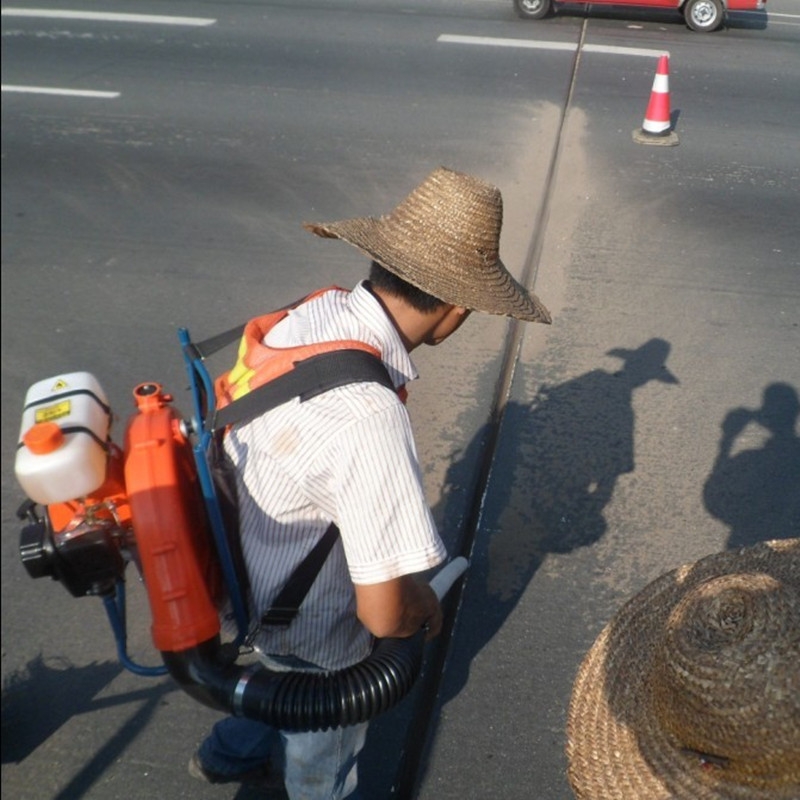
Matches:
[0,0,800,800]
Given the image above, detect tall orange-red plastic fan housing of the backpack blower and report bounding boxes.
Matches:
[124,383,223,652]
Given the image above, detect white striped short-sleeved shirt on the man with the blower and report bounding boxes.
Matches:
[225,282,446,669]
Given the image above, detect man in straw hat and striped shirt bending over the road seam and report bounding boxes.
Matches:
[190,168,550,800]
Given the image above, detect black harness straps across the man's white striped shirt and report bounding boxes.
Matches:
[211,346,395,626]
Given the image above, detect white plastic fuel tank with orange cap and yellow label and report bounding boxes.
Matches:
[14,372,111,505]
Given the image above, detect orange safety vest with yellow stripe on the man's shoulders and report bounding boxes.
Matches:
[214,286,406,409]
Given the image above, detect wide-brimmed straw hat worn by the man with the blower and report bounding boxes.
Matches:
[303,167,550,324]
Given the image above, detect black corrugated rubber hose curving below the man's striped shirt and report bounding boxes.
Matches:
[161,631,425,731]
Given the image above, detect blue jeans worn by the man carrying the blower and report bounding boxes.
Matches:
[198,656,368,800]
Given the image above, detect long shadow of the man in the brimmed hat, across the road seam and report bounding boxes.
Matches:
[373,339,678,798]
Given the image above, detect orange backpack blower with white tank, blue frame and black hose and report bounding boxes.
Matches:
[15,326,467,731]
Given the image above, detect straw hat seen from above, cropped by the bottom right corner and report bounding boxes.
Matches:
[567,539,800,800]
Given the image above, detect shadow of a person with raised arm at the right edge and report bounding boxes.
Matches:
[703,383,800,548]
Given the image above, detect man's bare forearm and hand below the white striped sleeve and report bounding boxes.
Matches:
[355,575,442,639]
